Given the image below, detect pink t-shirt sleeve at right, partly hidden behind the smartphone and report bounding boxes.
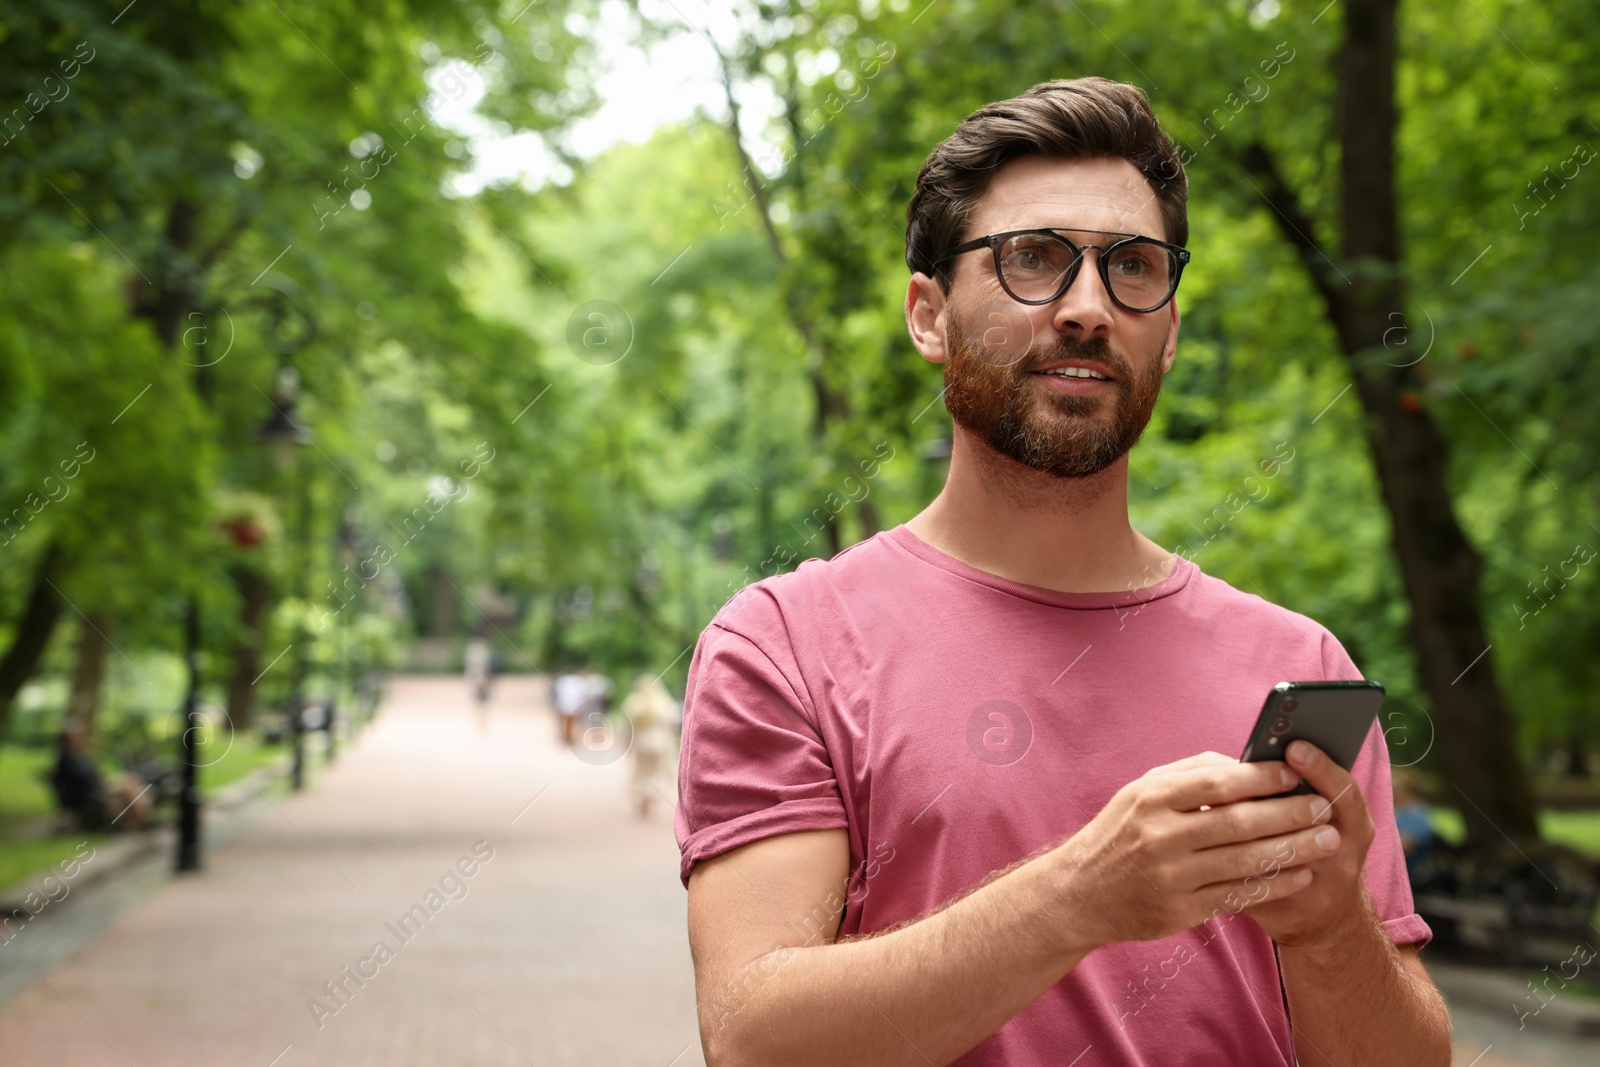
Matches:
[1322,633,1434,949]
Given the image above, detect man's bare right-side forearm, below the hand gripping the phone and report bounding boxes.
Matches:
[1278,893,1450,1067]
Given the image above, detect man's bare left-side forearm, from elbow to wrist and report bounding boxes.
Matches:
[702,856,1093,1067]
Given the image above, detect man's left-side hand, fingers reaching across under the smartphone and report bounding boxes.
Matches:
[1051,752,1337,947]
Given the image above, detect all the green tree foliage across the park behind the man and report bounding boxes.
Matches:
[0,0,1600,793]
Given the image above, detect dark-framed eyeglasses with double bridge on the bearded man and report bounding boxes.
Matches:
[933,230,1189,314]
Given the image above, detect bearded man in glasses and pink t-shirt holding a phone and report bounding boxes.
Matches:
[677,78,1450,1067]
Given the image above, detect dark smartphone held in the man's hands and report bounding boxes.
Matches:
[1238,681,1384,797]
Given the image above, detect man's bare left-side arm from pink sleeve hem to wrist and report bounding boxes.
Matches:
[690,830,1091,1067]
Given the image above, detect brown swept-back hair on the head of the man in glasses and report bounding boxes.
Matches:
[906,78,1189,293]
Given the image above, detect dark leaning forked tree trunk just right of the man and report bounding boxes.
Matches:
[1243,0,1539,843]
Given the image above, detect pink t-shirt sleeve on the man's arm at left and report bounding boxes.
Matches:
[674,611,848,886]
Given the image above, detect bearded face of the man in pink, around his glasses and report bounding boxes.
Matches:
[939,158,1178,478]
